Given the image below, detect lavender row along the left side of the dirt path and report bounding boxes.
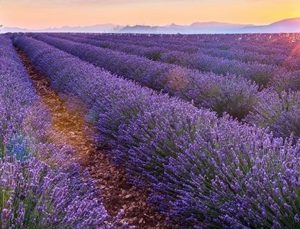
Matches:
[0,36,108,228]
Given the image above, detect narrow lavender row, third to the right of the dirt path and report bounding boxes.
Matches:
[52,33,288,87]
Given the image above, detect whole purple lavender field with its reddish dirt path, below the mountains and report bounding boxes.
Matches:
[0,33,300,229]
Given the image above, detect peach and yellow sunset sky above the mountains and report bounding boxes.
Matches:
[0,0,300,29]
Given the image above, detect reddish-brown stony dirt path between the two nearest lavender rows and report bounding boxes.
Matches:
[17,49,172,228]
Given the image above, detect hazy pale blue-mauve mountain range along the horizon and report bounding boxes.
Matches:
[1,18,300,34]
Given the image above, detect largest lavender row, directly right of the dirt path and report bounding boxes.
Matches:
[15,37,300,228]
